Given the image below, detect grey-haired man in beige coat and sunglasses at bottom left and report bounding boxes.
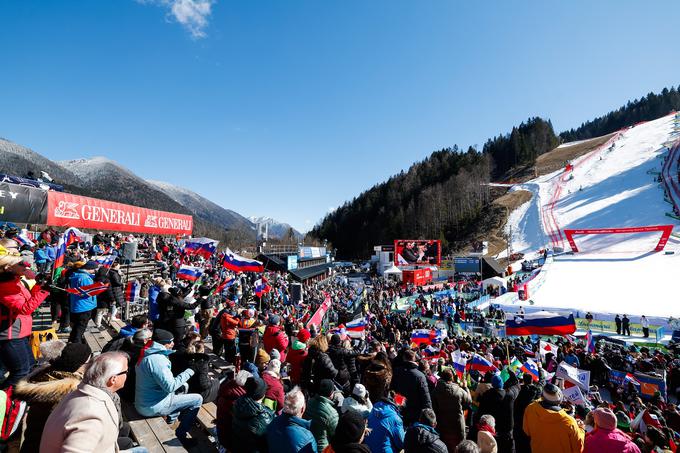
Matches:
[40,352,147,453]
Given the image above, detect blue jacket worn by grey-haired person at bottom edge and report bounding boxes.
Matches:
[267,414,318,453]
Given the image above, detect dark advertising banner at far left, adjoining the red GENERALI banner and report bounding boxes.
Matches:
[0,182,47,224]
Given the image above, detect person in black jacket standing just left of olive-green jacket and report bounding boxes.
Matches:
[392,349,432,426]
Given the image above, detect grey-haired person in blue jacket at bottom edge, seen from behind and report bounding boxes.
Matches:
[267,387,318,453]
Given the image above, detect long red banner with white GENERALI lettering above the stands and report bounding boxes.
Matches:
[47,190,194,234]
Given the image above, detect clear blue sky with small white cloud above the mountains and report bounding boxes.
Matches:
[0,0,680,230]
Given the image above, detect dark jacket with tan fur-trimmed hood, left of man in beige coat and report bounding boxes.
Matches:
[13,367,82,453]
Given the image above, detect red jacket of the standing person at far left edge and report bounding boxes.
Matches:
[0,277,50,340]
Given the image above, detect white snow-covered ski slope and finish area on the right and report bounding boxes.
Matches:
[506,115,680,322]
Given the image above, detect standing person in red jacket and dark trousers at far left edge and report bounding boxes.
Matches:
[0,239,50,388]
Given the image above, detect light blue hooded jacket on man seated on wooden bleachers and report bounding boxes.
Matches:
[135,341,194,417]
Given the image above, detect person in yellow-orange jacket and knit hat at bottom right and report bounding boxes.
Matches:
[523,384,585,453]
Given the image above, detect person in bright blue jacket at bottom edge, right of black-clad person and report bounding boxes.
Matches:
[364,398,405,453]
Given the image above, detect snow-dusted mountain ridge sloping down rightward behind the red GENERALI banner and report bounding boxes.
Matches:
[146,181,255,231]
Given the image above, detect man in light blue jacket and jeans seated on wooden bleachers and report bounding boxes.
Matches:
[135,329,203,448]
